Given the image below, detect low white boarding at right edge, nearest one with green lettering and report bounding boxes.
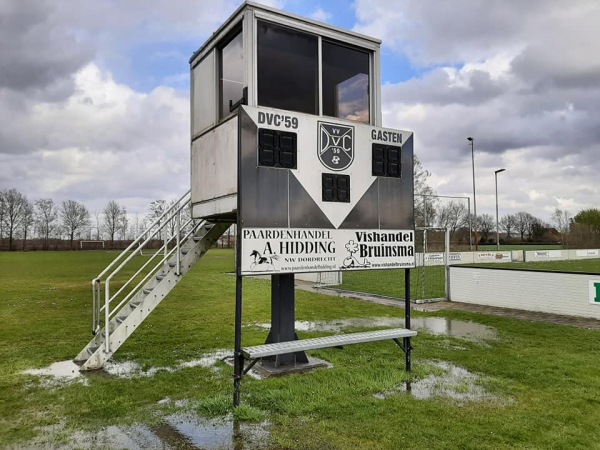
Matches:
[448,266,600,319]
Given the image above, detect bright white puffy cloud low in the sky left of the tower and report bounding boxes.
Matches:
[0,64,189,212]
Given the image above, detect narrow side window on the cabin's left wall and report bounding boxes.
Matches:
[219,31,244,119]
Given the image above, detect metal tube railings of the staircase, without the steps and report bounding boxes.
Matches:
[92,191,203,352]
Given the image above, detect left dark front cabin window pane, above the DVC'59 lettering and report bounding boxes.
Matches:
[258,22,319,114]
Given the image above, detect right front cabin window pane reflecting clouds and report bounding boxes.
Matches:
[323,41,369,123]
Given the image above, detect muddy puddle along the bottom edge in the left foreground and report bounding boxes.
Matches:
[25,414,270,450]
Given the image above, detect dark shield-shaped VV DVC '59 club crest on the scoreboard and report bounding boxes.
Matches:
[318,122,354,171]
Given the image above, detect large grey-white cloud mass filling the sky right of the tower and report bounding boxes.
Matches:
[355,0,600,218]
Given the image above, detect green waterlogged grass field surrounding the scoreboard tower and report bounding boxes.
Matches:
[0,250,600,449]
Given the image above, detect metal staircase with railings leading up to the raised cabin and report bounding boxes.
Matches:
[75,191,230,370]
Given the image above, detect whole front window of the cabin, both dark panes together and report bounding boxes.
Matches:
[257,21,370,123]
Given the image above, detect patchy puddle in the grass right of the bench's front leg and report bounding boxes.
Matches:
[374,361,499,403]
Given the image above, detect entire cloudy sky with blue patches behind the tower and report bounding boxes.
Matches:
[0,0,600,222]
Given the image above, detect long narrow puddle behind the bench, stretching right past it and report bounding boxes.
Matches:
[257,317,498,342]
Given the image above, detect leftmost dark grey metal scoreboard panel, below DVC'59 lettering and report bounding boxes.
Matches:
[238,108,289,227]
